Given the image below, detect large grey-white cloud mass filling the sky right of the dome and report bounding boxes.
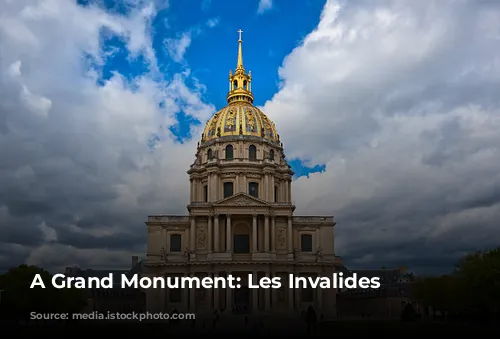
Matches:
[263,0,500,270]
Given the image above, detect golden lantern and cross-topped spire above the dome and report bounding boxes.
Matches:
[227,29,253,103]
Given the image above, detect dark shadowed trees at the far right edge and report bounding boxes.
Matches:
[415,247,500,321]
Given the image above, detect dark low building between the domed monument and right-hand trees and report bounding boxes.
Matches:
[337,267,421,319]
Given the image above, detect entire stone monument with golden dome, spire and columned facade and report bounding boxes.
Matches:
[144,31,341,319]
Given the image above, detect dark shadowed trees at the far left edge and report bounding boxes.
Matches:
[0,265,86,322]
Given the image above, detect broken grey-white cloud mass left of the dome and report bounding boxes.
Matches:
[0,0,214,269]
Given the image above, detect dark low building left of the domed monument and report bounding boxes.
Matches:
[65,256,146,316]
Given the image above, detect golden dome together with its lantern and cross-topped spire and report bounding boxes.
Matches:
[201,29,279,142]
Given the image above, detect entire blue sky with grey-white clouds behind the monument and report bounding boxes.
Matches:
[0,0,500,274]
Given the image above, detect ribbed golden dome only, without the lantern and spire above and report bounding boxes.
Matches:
[202,101,279,142]
